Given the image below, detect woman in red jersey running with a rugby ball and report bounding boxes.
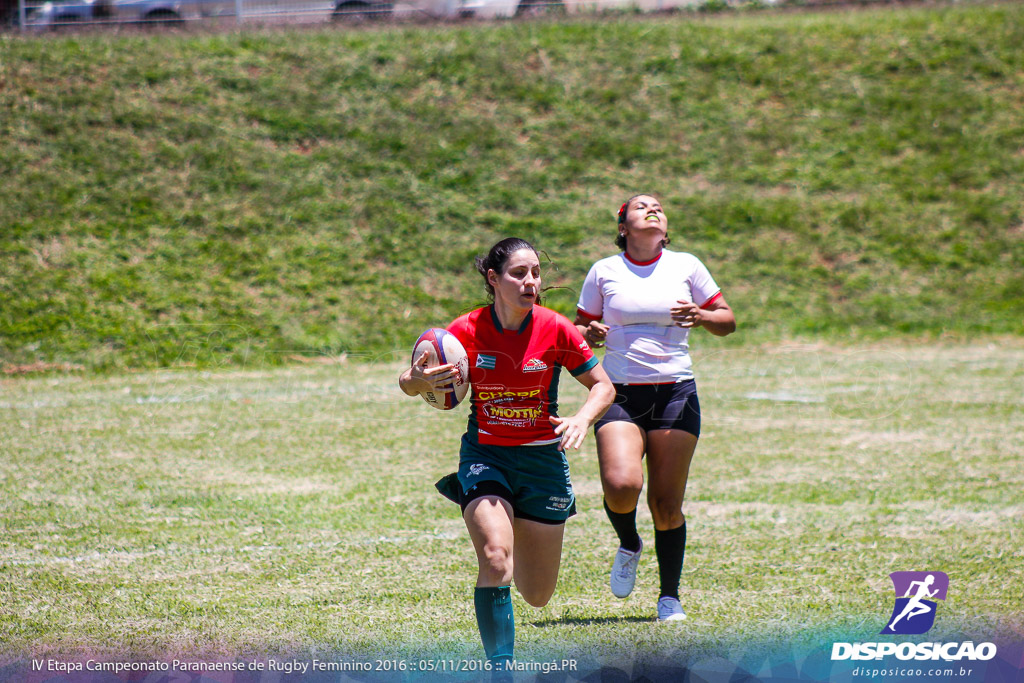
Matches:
[398,238,614,670]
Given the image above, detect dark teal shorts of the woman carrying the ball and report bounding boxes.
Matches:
[437,434,575,524]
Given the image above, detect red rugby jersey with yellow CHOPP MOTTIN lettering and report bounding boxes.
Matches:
[447,305,597,445]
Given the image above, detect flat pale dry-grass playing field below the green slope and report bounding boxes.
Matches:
[0,336,1024,673]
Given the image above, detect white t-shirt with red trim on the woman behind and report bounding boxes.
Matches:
[577,249,721,384]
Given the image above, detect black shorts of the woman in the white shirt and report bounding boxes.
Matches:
[594,380,700,436]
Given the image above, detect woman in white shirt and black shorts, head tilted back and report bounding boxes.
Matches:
[575,195,736,622]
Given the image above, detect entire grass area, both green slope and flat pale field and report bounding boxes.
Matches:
[0,2,1024,683]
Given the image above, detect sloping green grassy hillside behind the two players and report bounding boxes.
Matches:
[0,4,1024,369]
